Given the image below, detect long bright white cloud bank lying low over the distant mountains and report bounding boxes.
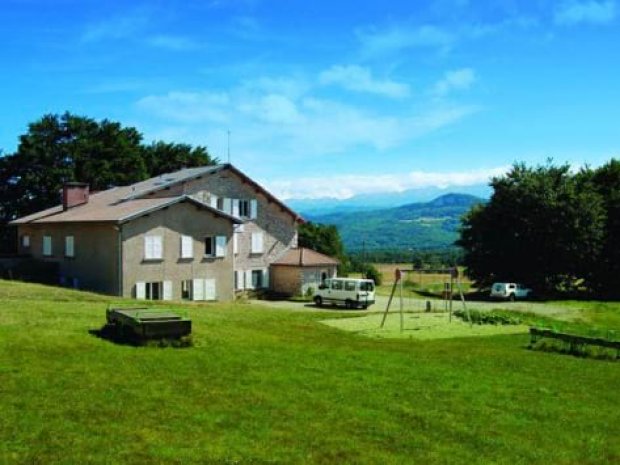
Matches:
[266,166,509,200]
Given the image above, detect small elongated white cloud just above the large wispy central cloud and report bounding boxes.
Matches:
[319,65,410,98]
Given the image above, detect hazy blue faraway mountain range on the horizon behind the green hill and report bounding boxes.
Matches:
[286,185,491,218]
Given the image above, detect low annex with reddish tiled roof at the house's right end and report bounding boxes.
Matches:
[271,247,340,295]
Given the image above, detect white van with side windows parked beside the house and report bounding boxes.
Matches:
[314,278,375,308]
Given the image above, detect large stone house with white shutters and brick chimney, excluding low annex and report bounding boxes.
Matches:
[11,164,310,300]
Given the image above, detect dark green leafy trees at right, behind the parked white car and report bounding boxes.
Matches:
[457,159,620,296]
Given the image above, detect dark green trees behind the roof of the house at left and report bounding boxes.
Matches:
[0,113,217,252]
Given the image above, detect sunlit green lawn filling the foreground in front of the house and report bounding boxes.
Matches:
[0,281,620,464]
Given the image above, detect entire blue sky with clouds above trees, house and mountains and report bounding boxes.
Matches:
[0,0,620,198]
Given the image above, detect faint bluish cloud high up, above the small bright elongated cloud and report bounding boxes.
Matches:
[357,25,456,57]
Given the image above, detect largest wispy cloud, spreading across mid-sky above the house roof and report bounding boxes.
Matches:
[137,86,479,158]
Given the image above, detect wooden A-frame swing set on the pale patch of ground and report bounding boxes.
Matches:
[381,267,472,332]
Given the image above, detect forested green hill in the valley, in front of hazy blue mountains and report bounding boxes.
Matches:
[300,194,485,251]
